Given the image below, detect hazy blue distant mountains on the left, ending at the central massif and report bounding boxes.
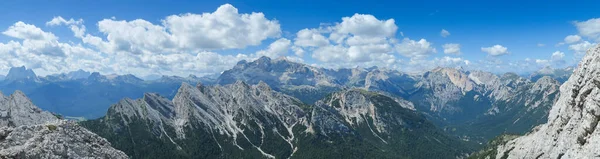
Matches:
[0,67,214,119]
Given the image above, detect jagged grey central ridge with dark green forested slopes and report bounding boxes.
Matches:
[82,81,468,158]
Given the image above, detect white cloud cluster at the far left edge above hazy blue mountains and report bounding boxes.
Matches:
[0,22,107,75]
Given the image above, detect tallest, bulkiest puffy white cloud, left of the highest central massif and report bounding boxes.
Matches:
[163,4,281,49]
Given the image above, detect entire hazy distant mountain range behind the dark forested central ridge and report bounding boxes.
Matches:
[0,57,569,147]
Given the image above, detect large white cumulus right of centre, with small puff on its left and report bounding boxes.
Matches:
[292,14,398,67]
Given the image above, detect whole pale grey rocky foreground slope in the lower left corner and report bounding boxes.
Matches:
[0,91,127,158]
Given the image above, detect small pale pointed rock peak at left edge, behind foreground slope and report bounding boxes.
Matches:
[0,91,58,127]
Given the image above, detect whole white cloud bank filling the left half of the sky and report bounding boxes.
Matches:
[0,4,284,76]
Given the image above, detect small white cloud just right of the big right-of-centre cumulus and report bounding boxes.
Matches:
[396,38,436,59]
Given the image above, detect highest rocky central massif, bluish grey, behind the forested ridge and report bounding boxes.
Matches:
[217,56,344,103]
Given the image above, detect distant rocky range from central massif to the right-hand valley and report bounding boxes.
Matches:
[216,57,560,143]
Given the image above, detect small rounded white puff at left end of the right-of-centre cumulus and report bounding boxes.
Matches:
[294,29,329,47]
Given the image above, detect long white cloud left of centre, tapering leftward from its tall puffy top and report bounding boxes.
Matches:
[82,4,281,54]
